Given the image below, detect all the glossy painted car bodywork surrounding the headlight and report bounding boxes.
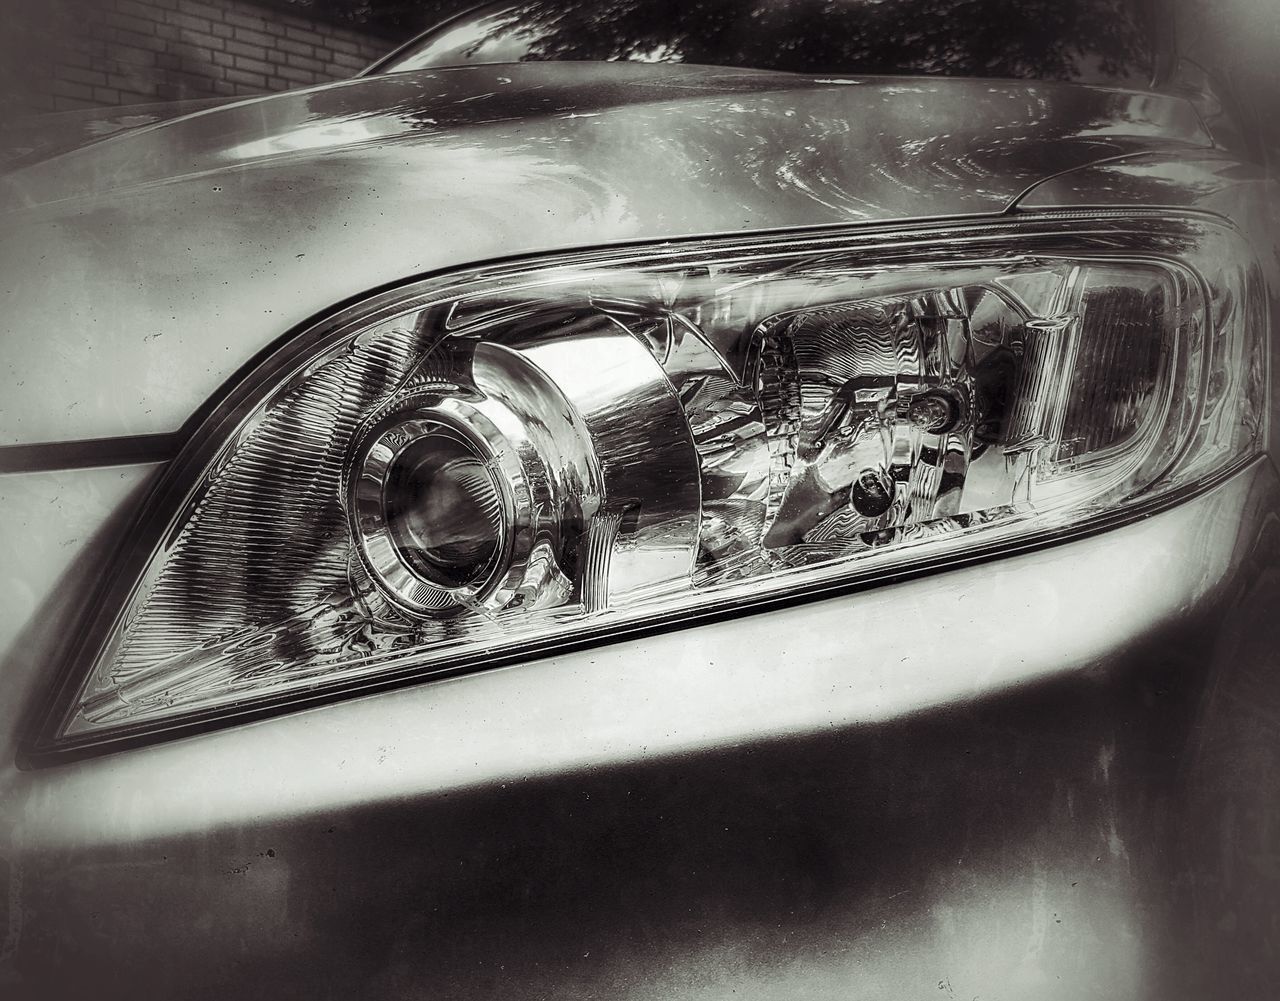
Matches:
[0,55,1280,1001]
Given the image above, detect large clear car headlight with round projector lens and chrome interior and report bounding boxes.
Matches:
[35,215,1266,745]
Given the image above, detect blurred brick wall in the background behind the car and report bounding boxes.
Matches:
[0,0,394,114]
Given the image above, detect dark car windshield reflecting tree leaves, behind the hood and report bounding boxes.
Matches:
[383,0,1155,84]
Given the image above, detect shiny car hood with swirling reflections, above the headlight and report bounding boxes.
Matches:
[0,64,1211,445]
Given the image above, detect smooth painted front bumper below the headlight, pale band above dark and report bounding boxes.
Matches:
[0,461,1280,998]
